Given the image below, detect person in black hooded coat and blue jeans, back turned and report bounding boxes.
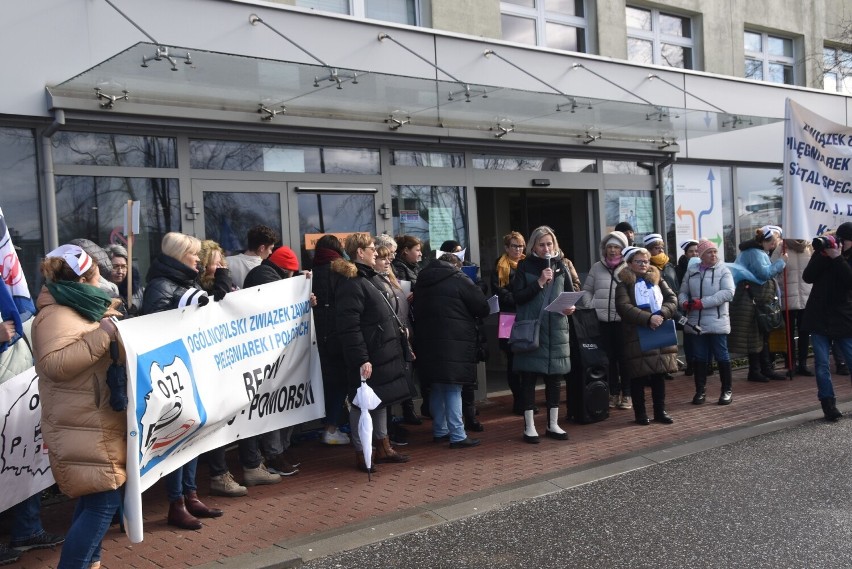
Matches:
[414,253,489,448]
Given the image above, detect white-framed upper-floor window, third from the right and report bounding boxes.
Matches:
[626,6,695,69]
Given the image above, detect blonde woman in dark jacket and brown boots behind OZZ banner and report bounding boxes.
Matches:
[142,231,222,530]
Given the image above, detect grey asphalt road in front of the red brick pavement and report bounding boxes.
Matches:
[303,417,852,569]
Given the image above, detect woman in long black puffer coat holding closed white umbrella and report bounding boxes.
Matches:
[331,233,411,472]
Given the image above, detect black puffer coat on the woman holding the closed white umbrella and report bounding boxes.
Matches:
[331,259,411,407]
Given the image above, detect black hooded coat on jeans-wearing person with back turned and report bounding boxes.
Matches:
[414,259,488,384]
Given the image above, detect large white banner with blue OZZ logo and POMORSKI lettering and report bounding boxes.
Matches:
[118,275,325,543]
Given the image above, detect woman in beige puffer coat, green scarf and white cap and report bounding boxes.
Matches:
[32,245,127,569]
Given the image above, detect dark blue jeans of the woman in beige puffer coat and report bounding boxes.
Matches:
[56,490,121,569]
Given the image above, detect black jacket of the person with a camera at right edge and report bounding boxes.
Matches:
[802,253,852,338]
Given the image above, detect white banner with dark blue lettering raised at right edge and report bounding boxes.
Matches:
[781,99,852,239]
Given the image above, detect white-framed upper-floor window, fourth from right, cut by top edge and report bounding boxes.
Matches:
[500,0,588,53]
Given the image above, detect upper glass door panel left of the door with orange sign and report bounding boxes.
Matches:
[191,179,289,255]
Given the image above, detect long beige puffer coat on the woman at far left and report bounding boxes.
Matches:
[32,288,127,498]
